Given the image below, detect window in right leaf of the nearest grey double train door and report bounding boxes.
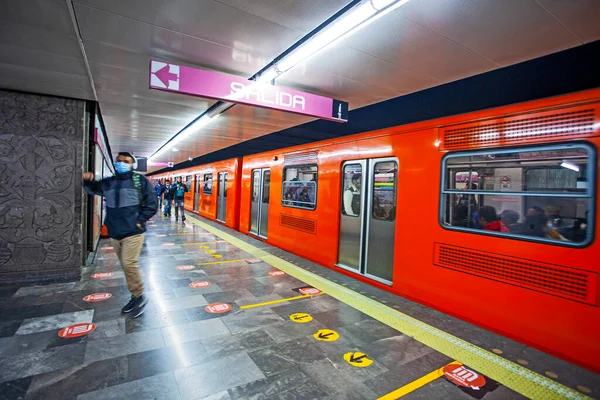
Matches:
[371,161,398,221]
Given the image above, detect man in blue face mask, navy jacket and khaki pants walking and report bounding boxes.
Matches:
[83,152,158,318]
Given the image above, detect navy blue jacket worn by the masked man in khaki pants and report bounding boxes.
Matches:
[83,172,158,239]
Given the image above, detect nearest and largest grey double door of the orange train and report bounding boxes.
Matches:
[337,158,398,285]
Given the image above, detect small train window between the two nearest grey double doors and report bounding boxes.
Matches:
[281,165,318,210]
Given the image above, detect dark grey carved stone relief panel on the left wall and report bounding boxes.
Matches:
[0,90,85,282]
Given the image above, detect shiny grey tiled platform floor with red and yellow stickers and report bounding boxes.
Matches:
[0,217,600,400]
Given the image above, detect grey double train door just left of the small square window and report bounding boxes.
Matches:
[250,168,271,239]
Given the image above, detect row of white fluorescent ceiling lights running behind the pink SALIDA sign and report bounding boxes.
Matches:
[149,0,409,160]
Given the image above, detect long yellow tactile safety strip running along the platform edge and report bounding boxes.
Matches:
[189,217,589,399]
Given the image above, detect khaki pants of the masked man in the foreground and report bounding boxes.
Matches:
[110,233,146,297]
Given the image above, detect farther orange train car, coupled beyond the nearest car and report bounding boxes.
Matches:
[151,158,241,229]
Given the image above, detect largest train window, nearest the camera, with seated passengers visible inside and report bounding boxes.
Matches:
[440,144,596,246]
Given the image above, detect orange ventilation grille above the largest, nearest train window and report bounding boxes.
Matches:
[441,109,594,150]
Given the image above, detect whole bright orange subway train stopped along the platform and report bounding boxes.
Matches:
[151,90,600,372]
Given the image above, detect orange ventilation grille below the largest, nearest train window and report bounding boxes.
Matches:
[434,243,598,304]
